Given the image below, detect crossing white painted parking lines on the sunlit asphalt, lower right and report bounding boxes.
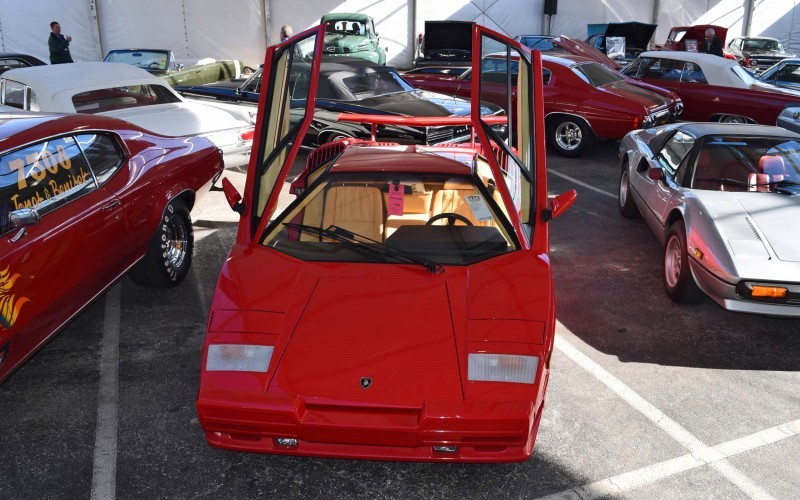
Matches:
[555,322,776,499]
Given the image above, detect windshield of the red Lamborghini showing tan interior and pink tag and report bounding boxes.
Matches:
[262,172,517,265]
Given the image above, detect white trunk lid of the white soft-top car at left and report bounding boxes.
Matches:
[99,102,249,136]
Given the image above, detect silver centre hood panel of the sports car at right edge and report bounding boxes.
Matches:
[737,193,800,262]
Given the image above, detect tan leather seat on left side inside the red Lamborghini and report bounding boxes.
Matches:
[322,186,384,241]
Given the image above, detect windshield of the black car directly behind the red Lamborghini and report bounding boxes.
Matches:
[317,67,414,101]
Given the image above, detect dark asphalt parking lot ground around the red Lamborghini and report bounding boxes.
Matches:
[0,142,800,499]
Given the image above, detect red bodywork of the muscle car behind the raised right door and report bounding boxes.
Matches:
[404,56,679,139]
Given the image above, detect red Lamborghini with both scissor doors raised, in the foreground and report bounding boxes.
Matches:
[197,25,575,462]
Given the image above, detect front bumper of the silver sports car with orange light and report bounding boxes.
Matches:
[689,259,800,318]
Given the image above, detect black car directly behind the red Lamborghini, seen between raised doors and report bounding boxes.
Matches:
[176,59,504,147]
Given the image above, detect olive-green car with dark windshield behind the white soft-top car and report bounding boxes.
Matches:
[103,49,244,87]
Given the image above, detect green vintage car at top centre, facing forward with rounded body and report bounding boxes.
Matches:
[320,12,386,64]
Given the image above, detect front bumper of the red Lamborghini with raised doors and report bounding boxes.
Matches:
[197,392,544,462]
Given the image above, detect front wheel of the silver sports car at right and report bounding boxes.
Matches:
[662,220,703,304]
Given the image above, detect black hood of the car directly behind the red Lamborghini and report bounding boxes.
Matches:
[346,90,500,116]
